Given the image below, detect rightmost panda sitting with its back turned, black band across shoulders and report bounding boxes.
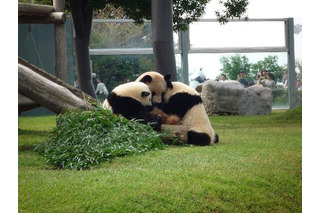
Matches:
[158,82,219,146]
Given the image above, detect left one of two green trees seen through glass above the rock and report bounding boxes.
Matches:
[220,54,254,81]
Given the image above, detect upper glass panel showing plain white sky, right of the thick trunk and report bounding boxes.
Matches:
[190,22,285,47]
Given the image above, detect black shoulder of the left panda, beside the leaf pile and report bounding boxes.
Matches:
[107,92,144,119]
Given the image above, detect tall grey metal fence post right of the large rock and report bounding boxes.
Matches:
[286,18,297,109]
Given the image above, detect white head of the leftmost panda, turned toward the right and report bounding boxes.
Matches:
[112,82,152,107]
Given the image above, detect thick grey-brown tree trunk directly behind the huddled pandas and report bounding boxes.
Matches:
[152,0,177,81]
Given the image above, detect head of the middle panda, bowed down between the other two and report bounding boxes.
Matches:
[136,71,171,103]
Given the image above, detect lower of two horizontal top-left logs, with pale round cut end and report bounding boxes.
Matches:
[18,12,66,24]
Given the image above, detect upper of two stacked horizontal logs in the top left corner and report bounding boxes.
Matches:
[18,2,54,16]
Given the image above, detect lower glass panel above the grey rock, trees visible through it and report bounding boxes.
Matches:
[188,53,289,108]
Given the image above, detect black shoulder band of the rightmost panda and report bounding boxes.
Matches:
[163,92,202,119]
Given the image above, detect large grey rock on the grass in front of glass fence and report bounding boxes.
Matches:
[201,80,272,115]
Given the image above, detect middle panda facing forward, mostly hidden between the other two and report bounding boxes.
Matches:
[136,71,180,125]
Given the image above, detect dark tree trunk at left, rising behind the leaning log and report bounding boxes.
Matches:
[70,0,97,98]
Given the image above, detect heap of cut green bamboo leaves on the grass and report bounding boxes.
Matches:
[35,108,165,170]
